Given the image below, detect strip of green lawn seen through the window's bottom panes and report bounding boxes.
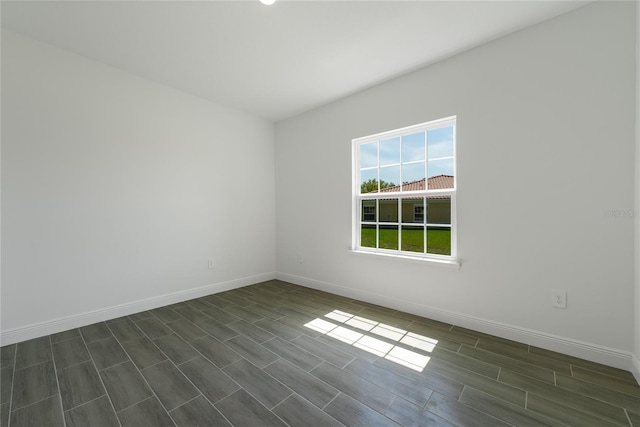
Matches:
[361,226,451,255]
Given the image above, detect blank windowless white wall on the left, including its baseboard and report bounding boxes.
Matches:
[2,32,275,344]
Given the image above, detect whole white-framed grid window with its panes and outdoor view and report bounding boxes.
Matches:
[353,117,456,260]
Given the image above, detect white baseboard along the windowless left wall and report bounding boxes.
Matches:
[0,272,276,346]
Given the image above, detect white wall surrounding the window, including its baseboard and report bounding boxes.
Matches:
[276,2,635,369]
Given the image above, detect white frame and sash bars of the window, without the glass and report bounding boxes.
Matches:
[352,116,460,267]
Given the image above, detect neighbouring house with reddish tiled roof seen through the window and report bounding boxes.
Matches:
[362,175,453,224]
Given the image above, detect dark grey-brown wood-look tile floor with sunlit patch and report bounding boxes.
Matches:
[0,280,640,427]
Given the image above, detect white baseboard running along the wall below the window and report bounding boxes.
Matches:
[276,272,640,372]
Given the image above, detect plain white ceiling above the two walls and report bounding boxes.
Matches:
[1,0,589,121]
